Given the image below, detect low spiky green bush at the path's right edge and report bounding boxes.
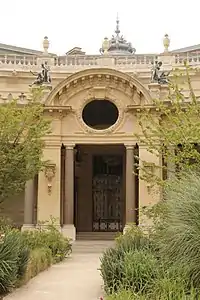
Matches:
[100,226,158,293]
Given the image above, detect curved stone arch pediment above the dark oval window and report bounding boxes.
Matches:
[45,68,151,106]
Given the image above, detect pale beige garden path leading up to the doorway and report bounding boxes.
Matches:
[4,241,114,300]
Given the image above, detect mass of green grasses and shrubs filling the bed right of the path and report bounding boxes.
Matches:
[101,170,200,300]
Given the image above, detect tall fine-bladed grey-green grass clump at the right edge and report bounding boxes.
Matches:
[158,171,200,288]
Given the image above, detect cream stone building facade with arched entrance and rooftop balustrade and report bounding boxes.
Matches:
[0,20,200,239]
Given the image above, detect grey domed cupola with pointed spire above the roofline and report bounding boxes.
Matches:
[100,18,136,55]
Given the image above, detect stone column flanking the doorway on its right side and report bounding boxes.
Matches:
[126,145,136,226]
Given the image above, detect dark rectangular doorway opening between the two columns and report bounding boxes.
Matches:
[74,145,125,232]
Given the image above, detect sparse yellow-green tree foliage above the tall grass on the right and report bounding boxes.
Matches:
[136,64,200,184]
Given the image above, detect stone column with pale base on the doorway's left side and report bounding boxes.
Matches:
[62,145,76,240]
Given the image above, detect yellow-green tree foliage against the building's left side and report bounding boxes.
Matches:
[0,89,50,202]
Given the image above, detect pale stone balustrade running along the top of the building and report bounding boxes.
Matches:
[0,53,200,72]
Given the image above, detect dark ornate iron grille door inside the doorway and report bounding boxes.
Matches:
[92,156,123,231]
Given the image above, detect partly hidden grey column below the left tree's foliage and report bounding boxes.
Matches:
[22,179,36,230]
